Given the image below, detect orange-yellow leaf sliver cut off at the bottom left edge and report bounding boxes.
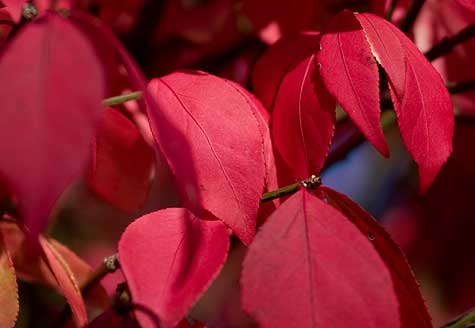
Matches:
[0,231,19,328]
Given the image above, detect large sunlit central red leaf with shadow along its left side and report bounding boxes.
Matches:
[149,72,265,244]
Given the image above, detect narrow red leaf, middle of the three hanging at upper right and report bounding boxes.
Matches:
[317,11,389,156]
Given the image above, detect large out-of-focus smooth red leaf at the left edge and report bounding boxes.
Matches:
[0,13,104,236]
